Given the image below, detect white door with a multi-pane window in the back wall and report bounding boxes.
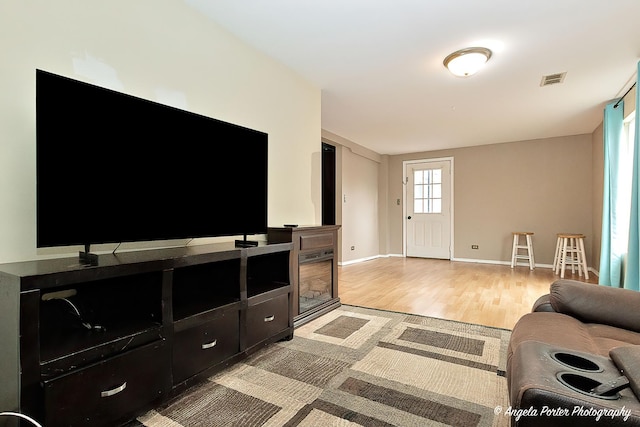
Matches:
[405,160,451,259]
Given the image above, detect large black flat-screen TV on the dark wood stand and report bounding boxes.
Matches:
[36,70,268,247]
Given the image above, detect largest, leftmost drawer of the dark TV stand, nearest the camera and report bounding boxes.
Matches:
[44,340,170,427]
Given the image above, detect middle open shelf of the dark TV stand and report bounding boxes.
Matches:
[173,258,240,321]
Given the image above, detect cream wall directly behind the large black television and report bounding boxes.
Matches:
[0,0,321,263]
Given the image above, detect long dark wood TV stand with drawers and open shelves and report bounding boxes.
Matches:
[0,243,293,427]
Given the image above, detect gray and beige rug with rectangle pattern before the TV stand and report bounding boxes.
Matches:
[136,305,511,427]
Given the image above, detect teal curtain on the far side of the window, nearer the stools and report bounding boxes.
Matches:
[598,101,629,287]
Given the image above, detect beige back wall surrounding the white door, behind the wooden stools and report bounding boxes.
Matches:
[387,135,594,265]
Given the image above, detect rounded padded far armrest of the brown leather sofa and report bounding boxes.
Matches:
[550,279,640,332]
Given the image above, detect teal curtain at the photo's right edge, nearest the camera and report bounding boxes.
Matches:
[624,62,640,291]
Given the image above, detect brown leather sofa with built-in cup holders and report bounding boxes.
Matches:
[506,279,640,427]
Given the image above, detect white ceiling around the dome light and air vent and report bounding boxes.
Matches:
[185,0,640,154]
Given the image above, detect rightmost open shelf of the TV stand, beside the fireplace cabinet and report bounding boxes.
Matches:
[247,251,291,298]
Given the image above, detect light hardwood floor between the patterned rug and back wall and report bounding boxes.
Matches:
[338,257,598,329]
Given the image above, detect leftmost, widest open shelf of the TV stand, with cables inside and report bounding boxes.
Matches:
[39,272,163,377]
